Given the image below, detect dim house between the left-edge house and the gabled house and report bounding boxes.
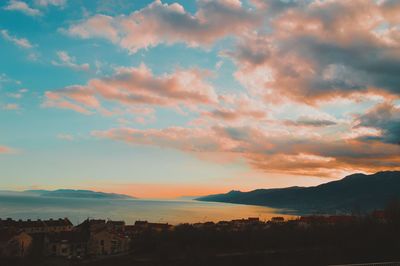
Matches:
[44,231,88,257]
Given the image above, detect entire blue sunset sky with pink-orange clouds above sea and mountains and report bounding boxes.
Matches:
[0,0,400,198]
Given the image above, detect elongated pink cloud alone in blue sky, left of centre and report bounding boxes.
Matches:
[44,64,218,114]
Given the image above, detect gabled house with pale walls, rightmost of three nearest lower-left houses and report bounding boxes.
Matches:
[88,228,129,256]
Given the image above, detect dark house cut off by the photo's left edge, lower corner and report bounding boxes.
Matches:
[0,229,33,257]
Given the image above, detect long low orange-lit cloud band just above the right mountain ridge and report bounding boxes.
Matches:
[93,127,400,177]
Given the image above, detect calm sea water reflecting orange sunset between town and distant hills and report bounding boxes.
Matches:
[0,195,290,224]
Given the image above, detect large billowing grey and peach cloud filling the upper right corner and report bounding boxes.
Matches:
[227,0,400,104]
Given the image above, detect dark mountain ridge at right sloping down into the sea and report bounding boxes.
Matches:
[197,171,400,213]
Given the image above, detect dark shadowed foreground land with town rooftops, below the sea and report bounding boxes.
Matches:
[0,201,400,266]
